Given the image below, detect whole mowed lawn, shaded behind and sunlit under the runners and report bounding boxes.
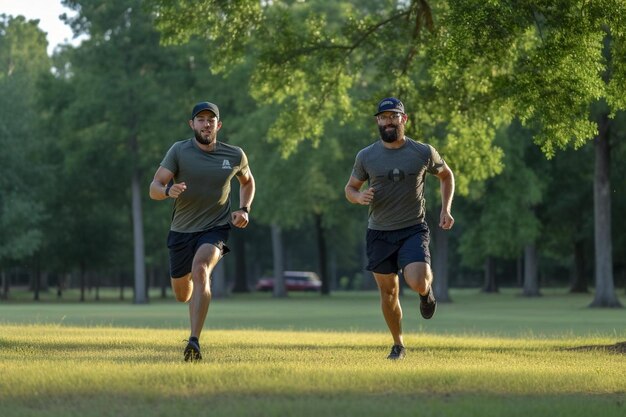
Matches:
[0,290,626,417]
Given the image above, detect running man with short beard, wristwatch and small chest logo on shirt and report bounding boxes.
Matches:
[150,102,255,361]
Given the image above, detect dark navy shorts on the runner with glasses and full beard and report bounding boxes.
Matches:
[366,223,430,274]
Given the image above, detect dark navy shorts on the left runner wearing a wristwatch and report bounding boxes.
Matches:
[167,224,230,278]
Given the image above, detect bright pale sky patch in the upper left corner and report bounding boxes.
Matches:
[0,0,80,55]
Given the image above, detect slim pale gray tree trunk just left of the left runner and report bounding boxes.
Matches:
[131,164,148,304]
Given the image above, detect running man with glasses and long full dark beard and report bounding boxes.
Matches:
[345,97,454,359]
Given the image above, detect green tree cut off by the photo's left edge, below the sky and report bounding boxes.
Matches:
[0,15,51,296]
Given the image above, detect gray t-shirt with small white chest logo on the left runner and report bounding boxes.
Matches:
[161,138,248,233]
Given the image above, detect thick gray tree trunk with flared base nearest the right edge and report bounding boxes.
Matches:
[589,114,622,307]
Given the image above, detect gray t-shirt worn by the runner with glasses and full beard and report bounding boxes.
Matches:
[352,137,445,230]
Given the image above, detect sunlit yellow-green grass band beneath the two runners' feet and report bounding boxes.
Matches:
[0,326,626,416]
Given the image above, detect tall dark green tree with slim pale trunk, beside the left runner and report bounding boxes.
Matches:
[48,0,210,303]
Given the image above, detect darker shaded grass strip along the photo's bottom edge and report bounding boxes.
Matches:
[0,387,624,417]
